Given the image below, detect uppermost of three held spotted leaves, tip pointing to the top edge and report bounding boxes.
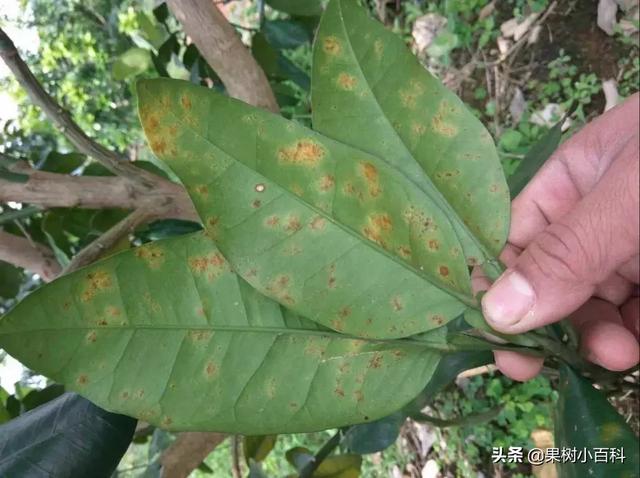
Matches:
[312,0,510,265]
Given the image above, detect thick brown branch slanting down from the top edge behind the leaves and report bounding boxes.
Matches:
[167,0,279,113]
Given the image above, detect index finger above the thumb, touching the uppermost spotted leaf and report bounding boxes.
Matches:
[509,94,639,248]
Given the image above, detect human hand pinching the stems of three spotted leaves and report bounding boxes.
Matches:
[482,93,640,380]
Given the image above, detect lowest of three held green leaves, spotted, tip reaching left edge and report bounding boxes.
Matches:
[0,232,444,434]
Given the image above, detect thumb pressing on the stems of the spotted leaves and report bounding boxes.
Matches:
[482,136,639,334]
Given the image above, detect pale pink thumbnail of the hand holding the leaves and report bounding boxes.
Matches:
[482,271,536,326]
